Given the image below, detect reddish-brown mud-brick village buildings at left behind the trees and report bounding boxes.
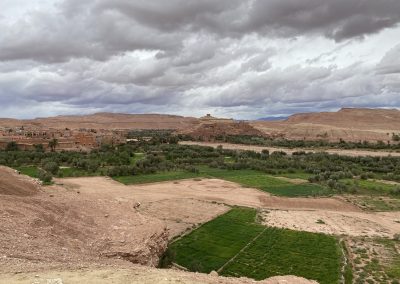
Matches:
[0,127,127,150]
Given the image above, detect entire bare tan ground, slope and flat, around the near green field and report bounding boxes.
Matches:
[0,165,400,284]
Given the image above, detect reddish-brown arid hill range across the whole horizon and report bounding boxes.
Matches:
[0,108,400,143]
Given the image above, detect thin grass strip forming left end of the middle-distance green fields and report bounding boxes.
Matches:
[113,171,200,185]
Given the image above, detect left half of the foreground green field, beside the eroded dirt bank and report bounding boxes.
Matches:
[169,208,264,273]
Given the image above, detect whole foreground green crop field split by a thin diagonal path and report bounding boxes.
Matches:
[168,208,341,284]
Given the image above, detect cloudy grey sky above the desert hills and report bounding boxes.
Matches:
[0,0,400,119]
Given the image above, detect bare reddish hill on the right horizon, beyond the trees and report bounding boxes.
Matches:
[250,108,400,142]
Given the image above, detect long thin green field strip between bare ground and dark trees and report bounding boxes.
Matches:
[114,166,332,197]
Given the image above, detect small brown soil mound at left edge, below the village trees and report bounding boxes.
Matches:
[0,166,40,196]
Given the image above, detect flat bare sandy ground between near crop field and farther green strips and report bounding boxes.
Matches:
[55,177,400,240]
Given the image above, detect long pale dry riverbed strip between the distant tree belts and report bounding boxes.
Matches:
[179,141,400,157]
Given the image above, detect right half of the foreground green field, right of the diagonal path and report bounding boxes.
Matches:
[222,228,341,283]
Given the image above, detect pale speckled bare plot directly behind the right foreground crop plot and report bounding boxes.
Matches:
[261,210,400,238]
